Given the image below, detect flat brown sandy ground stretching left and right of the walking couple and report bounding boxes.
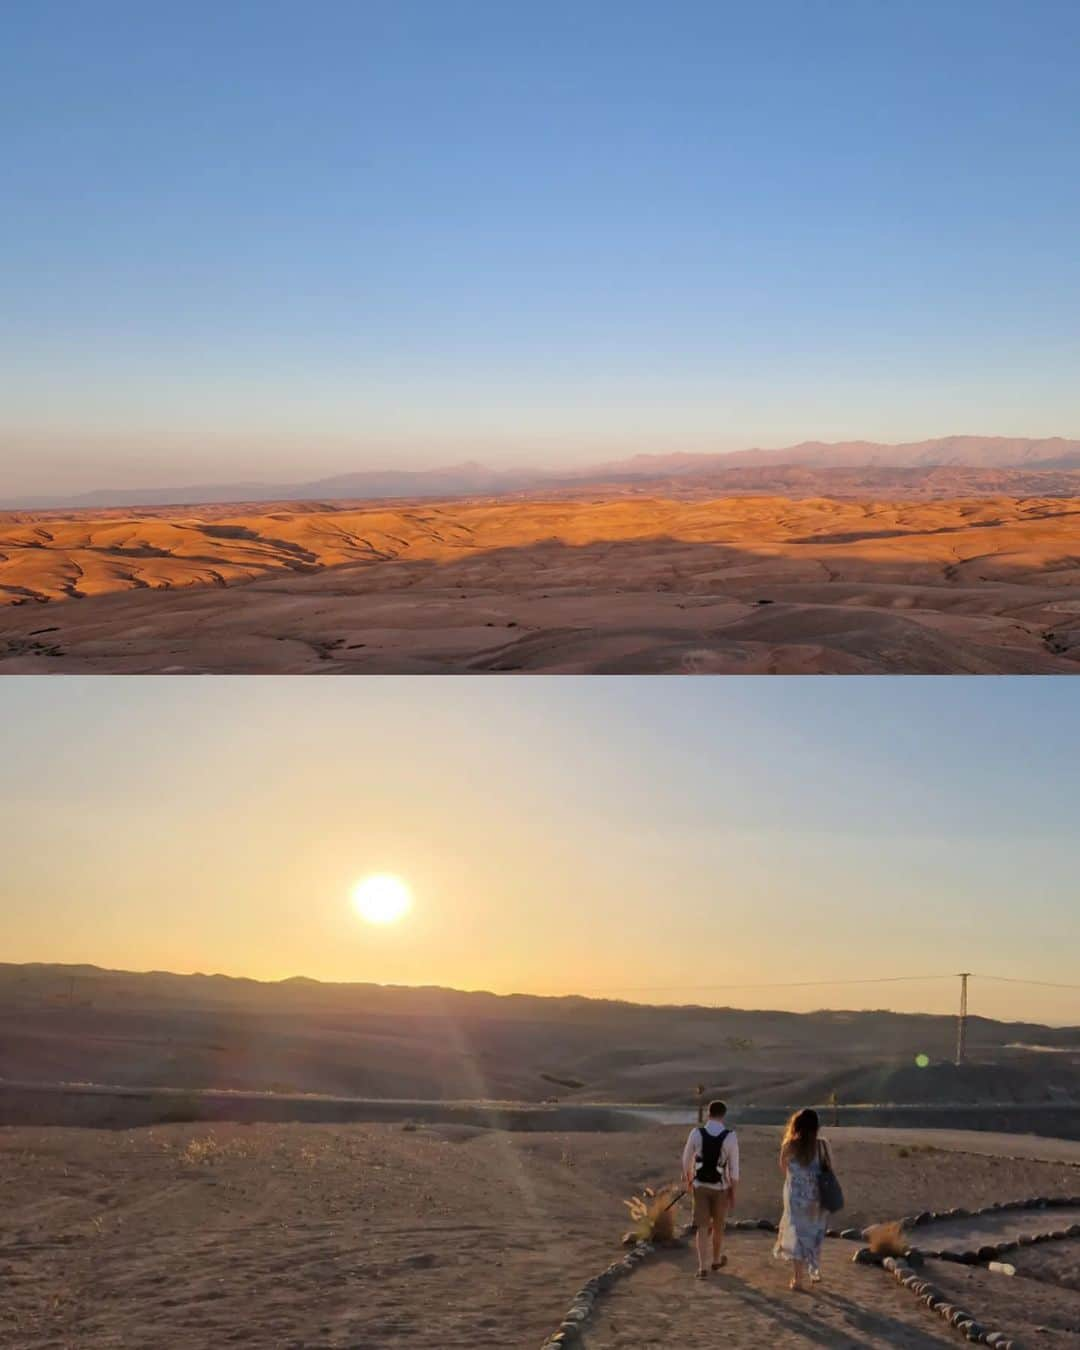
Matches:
[0,1125,1080,1350]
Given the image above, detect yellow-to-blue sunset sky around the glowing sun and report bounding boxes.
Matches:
[0,676,1080,1023]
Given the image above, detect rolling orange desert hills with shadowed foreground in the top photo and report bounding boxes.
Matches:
[0,497,1080,674]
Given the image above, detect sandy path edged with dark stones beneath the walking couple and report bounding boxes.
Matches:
[555,1197,1080,1350]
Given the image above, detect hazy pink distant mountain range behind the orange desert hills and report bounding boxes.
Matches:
[8,436,1080,510]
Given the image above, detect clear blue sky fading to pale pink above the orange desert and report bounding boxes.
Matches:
[0,0,1080,495]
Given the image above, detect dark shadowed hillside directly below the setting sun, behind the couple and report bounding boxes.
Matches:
[0,965,1080,1104]
